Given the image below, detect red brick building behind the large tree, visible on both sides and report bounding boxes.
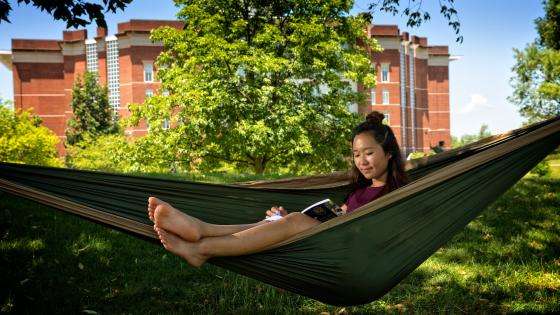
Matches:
[0,20,451,154]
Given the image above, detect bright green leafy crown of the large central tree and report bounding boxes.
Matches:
[130,0,378,173]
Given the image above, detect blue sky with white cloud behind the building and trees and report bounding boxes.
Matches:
[0,0,545,137]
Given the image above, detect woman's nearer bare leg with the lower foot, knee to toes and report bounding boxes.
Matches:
[156,212,320,267]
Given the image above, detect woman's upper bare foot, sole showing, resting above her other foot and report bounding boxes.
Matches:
[148,197,201,242]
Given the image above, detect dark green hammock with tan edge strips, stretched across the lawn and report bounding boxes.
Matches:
[0,117,560,305]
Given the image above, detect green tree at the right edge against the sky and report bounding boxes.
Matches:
[508,0,560,123]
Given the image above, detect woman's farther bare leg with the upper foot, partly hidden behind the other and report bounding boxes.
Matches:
[148,197,264,242]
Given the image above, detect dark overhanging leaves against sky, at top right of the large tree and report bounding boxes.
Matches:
[369,0,463,43]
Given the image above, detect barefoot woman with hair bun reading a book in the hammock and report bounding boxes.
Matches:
[148,112,408,267]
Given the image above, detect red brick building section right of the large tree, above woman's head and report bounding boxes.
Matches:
[359,25,451,154]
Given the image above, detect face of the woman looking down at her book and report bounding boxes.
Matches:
[352,132,391,186]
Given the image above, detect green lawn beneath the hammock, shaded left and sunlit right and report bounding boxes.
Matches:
[0,154,560,314]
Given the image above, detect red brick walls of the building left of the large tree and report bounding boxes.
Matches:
[12,20,183,154]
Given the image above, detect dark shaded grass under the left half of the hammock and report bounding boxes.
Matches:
[0,193,305,314]
